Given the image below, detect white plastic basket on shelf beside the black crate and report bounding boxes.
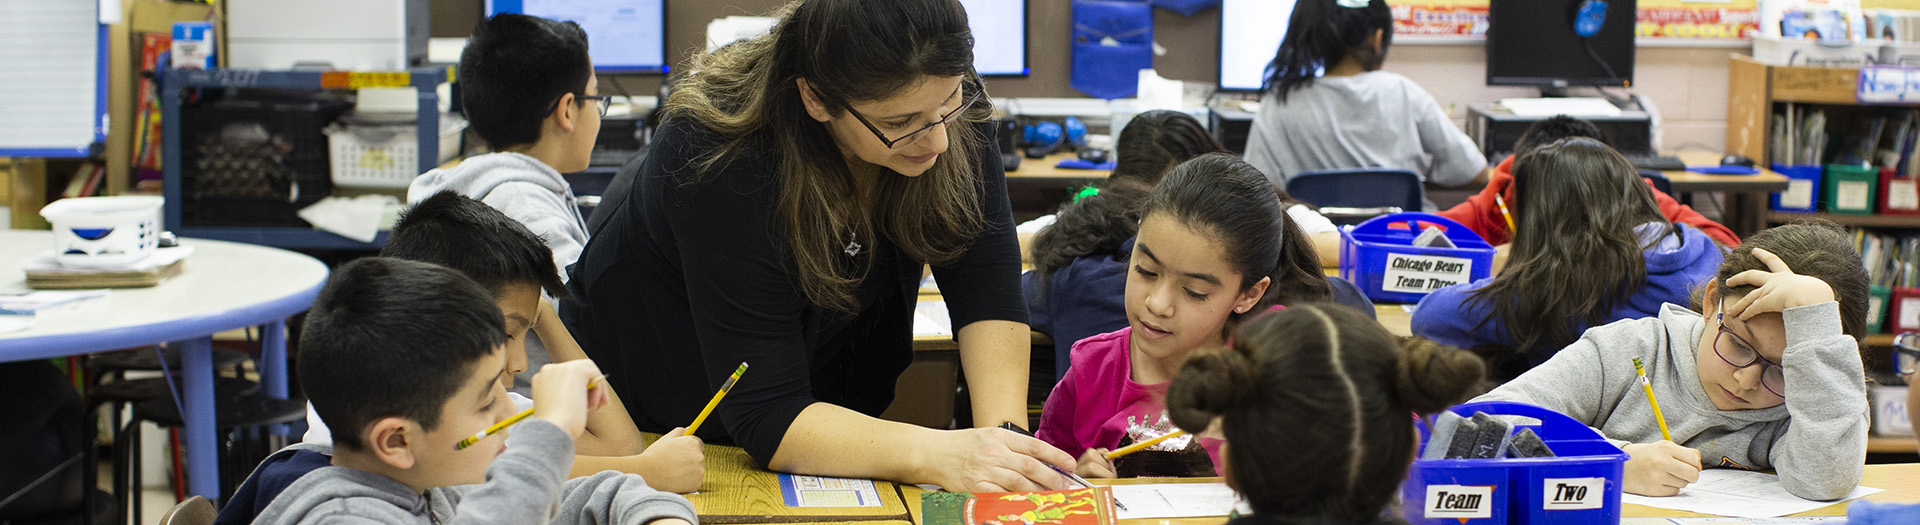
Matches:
[326,115,467,188]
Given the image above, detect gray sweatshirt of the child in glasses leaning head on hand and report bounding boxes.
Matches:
[1475,302,1868,500]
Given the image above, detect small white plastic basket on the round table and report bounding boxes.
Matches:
[40,196,165,267]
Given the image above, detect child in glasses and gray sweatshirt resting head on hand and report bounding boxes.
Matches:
[1476,222,1868,500]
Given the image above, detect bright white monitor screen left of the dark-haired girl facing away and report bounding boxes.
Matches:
[1219,0,1296,92]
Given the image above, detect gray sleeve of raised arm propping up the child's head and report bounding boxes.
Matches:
[1758,302,1868,500]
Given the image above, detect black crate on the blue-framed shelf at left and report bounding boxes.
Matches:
[180,90,353,227]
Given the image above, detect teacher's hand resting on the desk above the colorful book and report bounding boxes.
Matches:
[925,429,1073,492]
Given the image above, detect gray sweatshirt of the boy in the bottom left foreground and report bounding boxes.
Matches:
[253,419,699,525]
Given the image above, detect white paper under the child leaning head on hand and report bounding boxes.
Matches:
[1620,469,1880,517]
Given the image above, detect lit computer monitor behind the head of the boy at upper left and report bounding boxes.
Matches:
[486,0,668,73]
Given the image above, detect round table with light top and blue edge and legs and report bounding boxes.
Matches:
[0,231,326,500]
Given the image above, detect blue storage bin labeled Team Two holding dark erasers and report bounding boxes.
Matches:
[1400,402,1626,525]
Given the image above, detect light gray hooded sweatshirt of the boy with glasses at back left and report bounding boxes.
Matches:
[407,152,588,283]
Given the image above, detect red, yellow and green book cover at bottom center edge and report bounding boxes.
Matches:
[920,487,1116,525]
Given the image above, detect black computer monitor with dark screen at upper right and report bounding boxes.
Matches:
[1486,0,1638,96]
